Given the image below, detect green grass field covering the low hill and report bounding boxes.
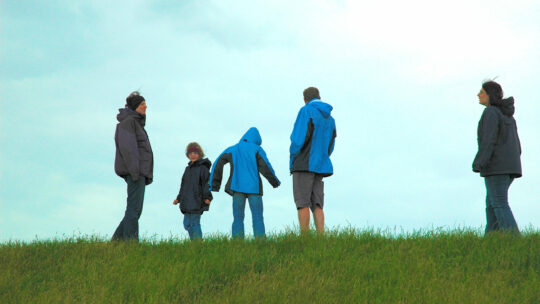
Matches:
[0,229,540,304]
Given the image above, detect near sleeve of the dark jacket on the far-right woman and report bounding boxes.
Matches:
[473,107,500,172]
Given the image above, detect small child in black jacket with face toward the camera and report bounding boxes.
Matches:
[173,142,212,240]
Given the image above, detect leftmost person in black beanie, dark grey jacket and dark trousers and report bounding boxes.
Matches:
[112,91,154,241]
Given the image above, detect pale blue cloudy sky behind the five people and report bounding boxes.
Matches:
[0,0,540,242]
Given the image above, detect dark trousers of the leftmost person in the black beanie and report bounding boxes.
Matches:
[112,175,146,241]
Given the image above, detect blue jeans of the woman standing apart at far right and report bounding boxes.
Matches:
[484,175,519,233]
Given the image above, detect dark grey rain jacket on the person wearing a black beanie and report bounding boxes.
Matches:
[114,107,154,185]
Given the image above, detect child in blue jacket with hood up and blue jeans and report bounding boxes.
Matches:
[210,128,281,238]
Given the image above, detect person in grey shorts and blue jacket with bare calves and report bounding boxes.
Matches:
[289,87,336,233]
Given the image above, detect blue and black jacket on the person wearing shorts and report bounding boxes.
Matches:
[289,98,337,176]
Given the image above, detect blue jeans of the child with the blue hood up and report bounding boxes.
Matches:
[232,192,265,238]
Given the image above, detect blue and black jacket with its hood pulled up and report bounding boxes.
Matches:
[210,128,280,195]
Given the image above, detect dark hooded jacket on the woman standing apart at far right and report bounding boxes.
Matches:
[473,97,521,178]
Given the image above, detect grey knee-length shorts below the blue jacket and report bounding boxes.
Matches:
[293,172,324,211]
